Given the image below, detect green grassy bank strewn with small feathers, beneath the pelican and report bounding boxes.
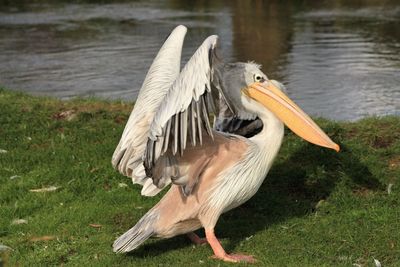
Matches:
[0,90,400,266]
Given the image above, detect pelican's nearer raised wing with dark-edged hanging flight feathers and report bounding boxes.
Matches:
[144,35,218,191]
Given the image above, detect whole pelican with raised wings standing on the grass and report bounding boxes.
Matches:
[112,25,339,262]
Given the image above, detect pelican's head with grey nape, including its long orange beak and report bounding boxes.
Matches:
[217,63,340,151]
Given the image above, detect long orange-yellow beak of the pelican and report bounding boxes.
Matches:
[243,81,340,152]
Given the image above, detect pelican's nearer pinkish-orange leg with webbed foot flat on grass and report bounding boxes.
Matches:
[206,229,256,263]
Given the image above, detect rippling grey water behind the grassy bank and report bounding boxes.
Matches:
[0,0,400,120]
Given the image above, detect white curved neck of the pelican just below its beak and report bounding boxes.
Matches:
[250,110,284,158]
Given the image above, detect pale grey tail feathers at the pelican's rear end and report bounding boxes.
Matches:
[113,210,158,253]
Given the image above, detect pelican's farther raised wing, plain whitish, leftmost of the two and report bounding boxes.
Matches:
[112,25,187,191]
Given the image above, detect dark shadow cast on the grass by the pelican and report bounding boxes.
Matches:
[129,141,383,257]
